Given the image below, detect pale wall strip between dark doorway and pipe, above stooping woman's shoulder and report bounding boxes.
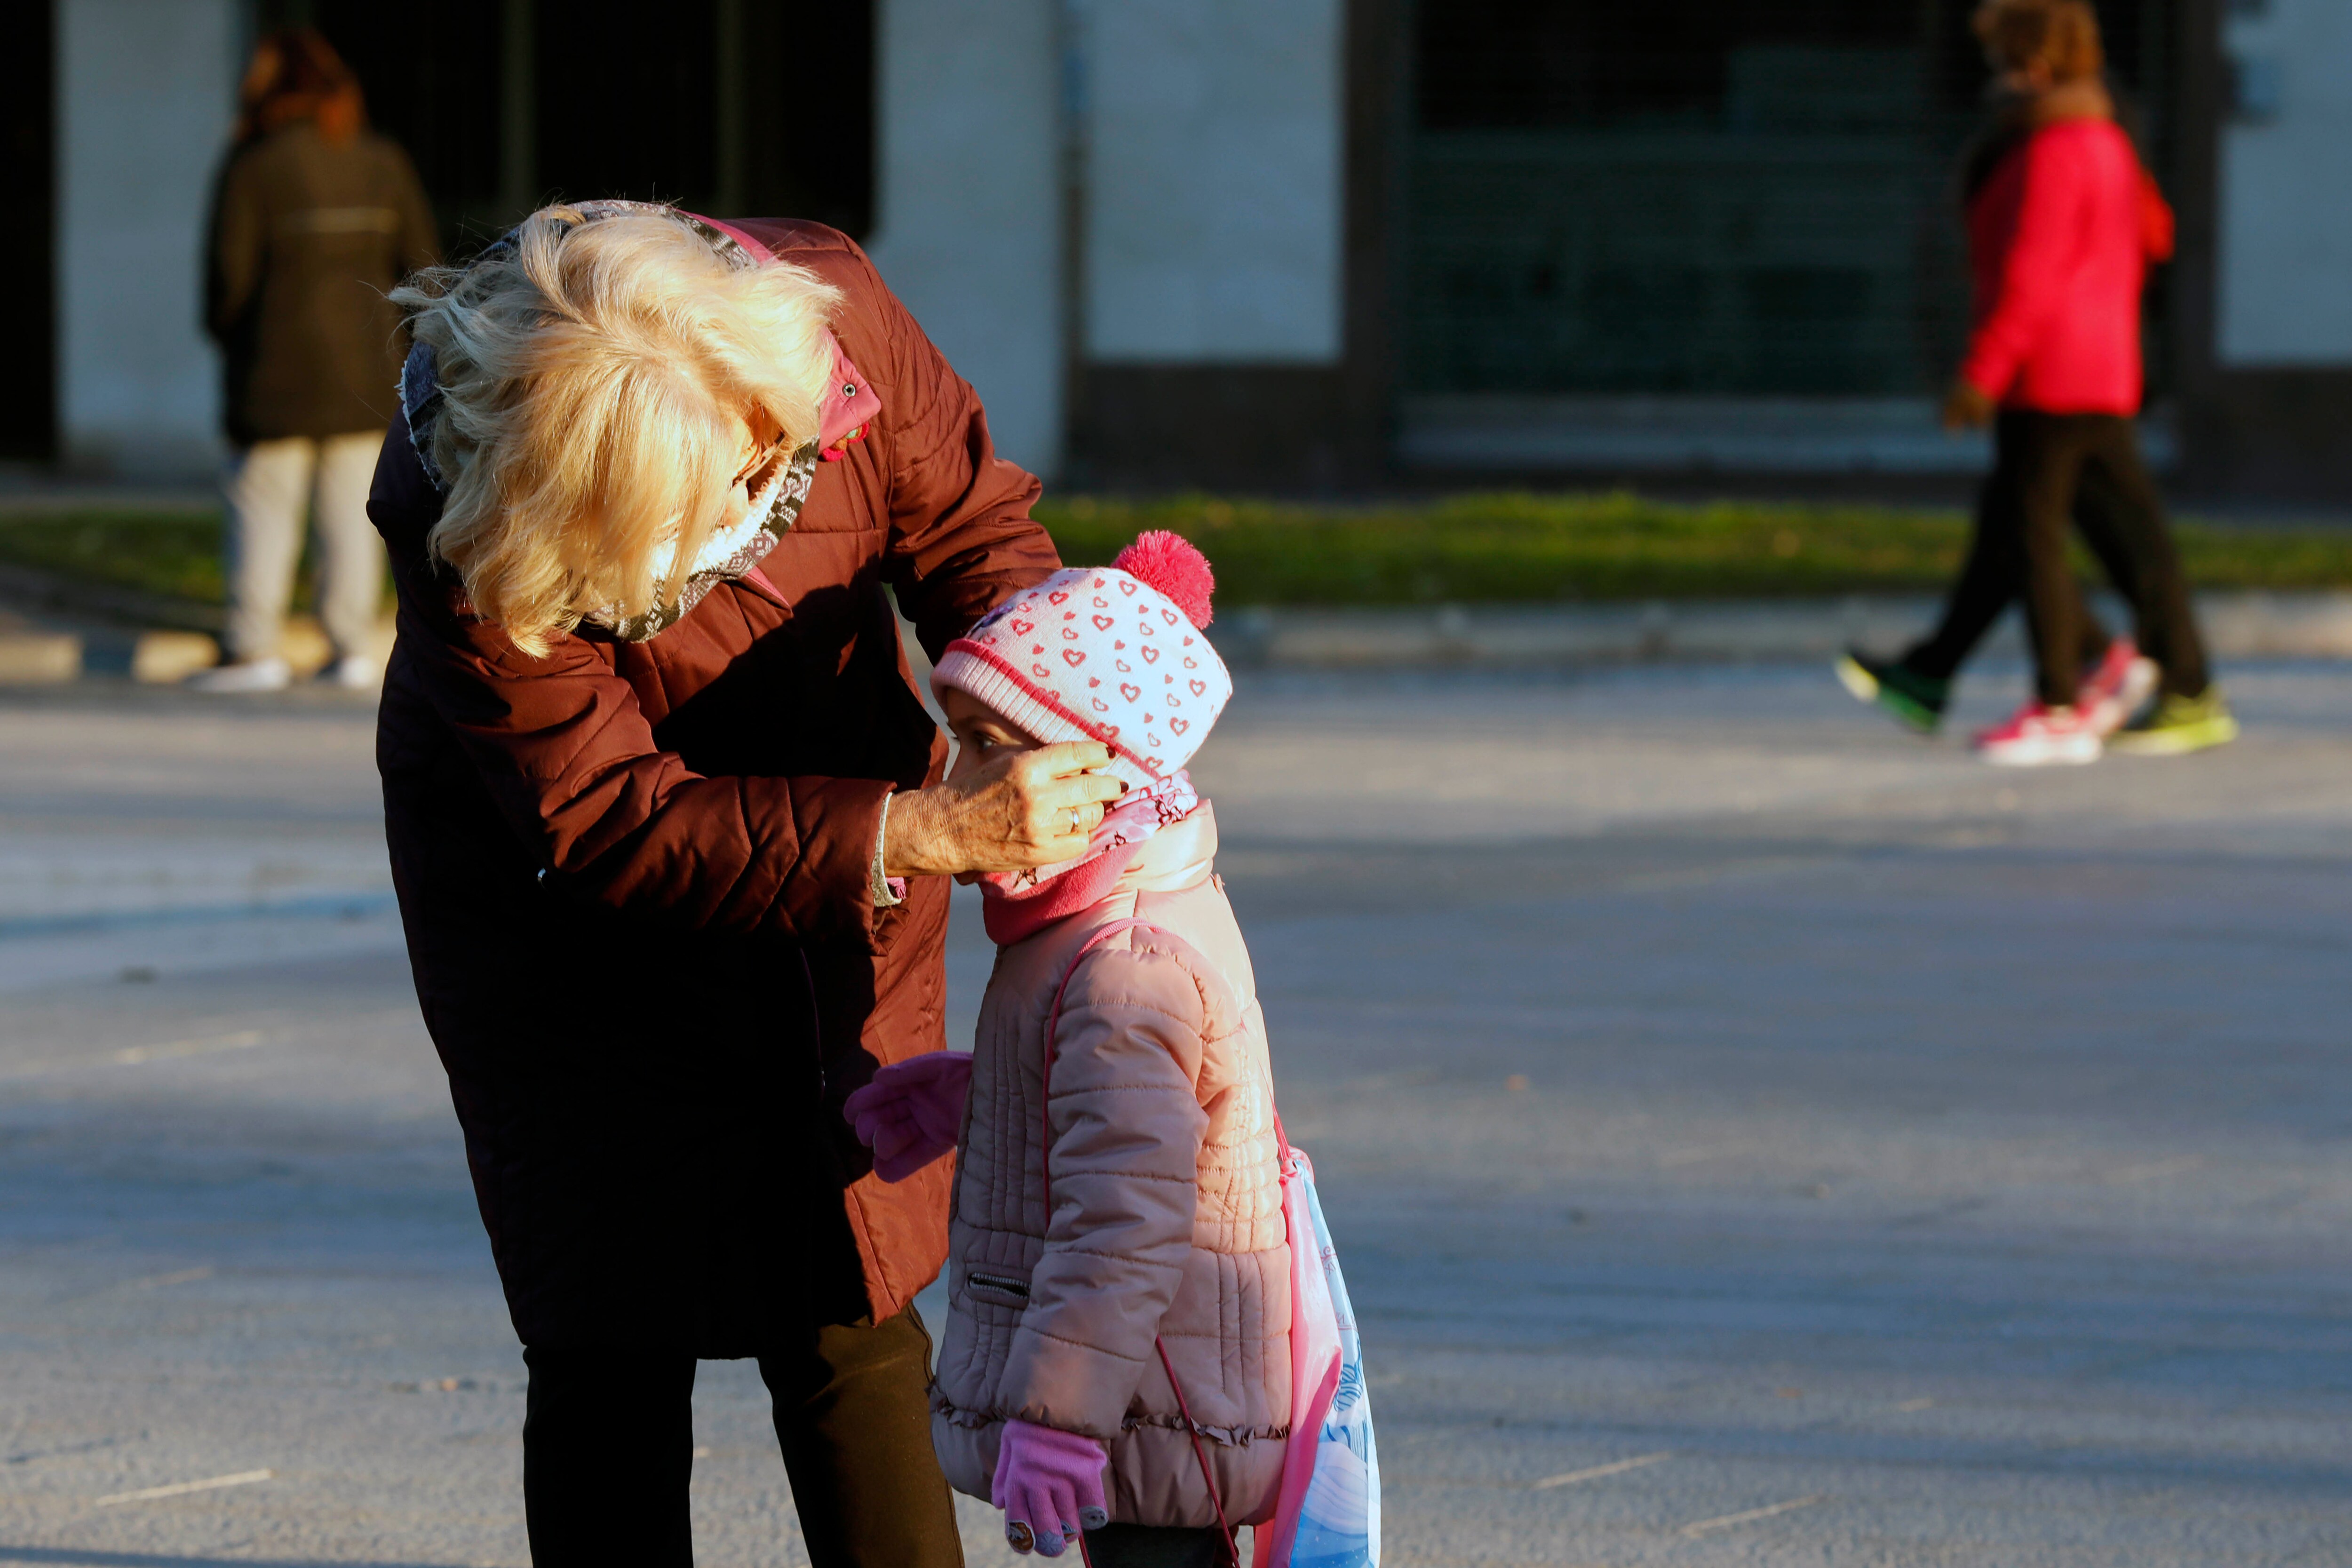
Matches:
[868,0,1063,475]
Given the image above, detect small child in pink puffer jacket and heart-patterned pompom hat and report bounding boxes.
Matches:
[849,533,1291,1568]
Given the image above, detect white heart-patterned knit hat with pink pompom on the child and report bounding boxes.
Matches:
[931,529,1232,788]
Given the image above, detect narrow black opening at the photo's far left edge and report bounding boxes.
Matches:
[0,0,56,463]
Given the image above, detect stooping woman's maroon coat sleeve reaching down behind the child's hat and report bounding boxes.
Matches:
[858,256,1061,658]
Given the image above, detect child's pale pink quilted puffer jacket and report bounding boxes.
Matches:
[931,804,1291,1526]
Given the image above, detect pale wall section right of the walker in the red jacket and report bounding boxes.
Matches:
[2218,0,2352,367]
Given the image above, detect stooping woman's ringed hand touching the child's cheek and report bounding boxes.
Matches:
[882,740,1127,877]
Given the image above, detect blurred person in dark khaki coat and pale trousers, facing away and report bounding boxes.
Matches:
[191,28,437,691]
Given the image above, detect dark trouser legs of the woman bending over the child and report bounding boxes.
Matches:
[522,1307,964,1568]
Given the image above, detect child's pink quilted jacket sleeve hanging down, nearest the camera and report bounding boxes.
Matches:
[1002,947,1209,1441]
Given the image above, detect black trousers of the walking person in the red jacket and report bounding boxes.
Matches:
[1903,409,2211,705]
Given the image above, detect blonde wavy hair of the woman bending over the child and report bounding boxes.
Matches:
[393,207,842,656]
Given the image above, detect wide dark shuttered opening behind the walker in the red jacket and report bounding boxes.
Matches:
[1402,0,2169,397]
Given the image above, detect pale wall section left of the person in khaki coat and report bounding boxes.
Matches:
[56,0,242,477]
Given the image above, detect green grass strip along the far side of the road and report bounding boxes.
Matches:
[0,491,2352,606]
